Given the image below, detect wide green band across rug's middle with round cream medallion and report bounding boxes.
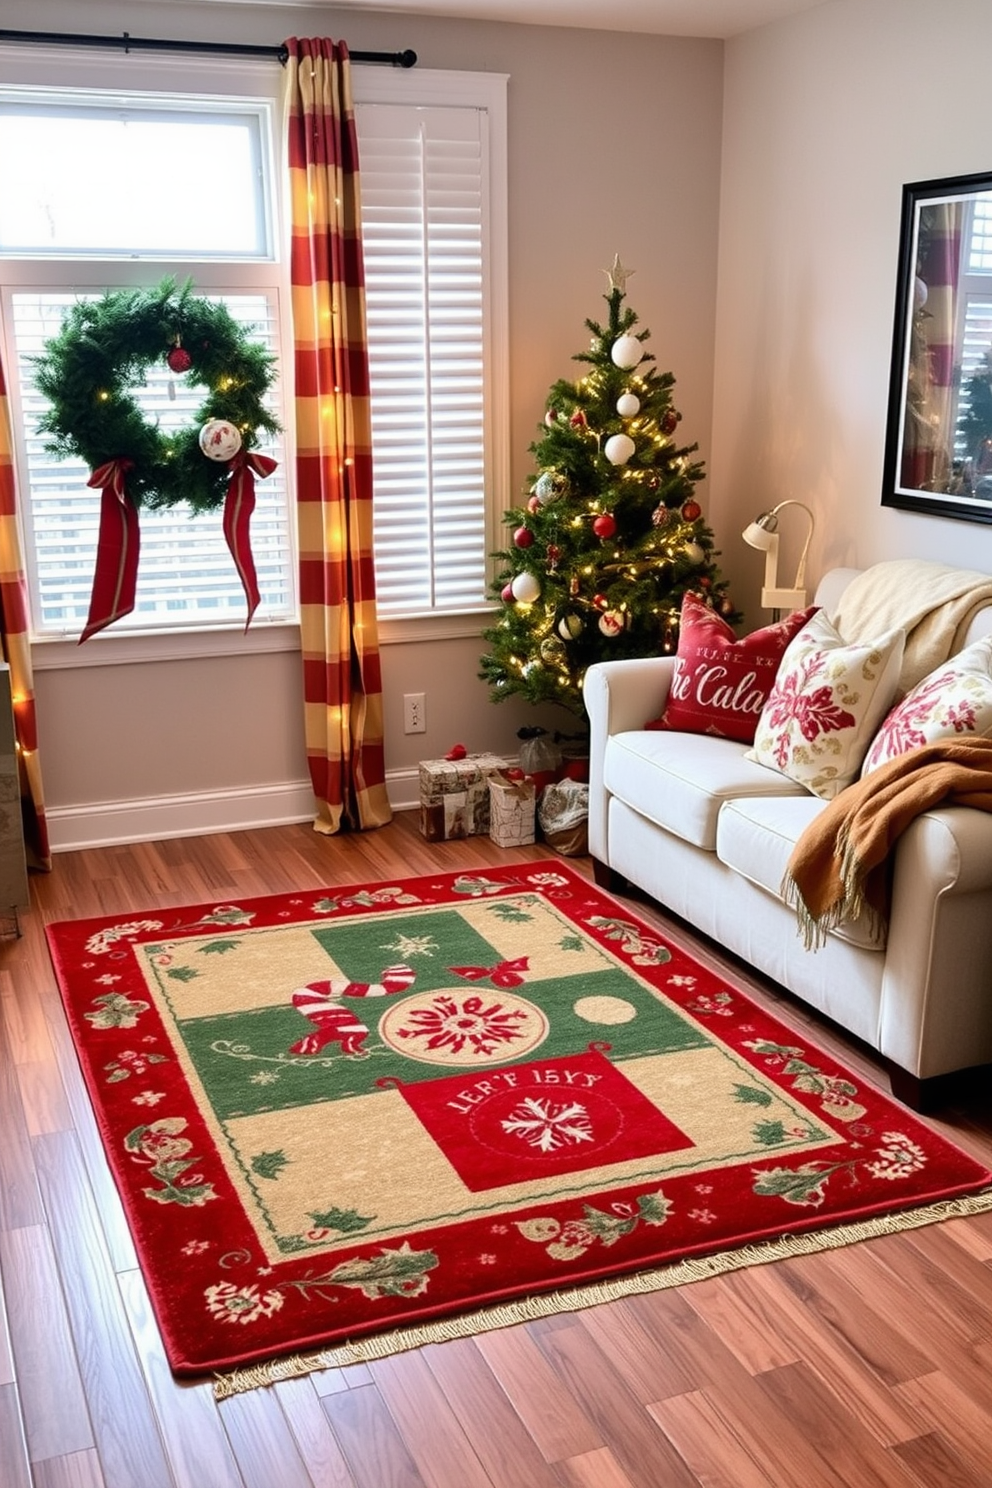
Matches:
[177,967,711,1120]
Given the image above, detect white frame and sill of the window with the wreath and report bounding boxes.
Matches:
[0,45,299,670]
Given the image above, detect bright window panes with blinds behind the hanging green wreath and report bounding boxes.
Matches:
[0,52,296,640]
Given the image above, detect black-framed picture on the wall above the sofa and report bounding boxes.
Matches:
[882,171,992,522]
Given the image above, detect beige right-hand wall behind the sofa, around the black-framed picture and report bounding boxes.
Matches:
[712,0,992,616]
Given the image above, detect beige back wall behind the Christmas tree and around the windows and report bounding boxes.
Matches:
[3,0,723,844]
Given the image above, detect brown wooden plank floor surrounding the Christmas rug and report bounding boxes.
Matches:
[0,814,992,1488]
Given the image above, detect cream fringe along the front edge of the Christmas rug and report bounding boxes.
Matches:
[214,1189,992,1400]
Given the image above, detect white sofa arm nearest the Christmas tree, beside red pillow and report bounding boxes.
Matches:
[582,656,675,868]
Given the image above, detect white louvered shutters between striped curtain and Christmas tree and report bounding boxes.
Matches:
[355,90,503,618]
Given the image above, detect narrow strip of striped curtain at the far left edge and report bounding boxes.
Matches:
[0,352,52,869]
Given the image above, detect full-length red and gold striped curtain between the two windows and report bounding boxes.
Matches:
[286,39,391,832]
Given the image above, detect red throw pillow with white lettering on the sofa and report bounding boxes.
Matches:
[644,594,817,744]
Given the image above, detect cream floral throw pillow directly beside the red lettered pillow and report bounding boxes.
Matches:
[748,610,906,801]
